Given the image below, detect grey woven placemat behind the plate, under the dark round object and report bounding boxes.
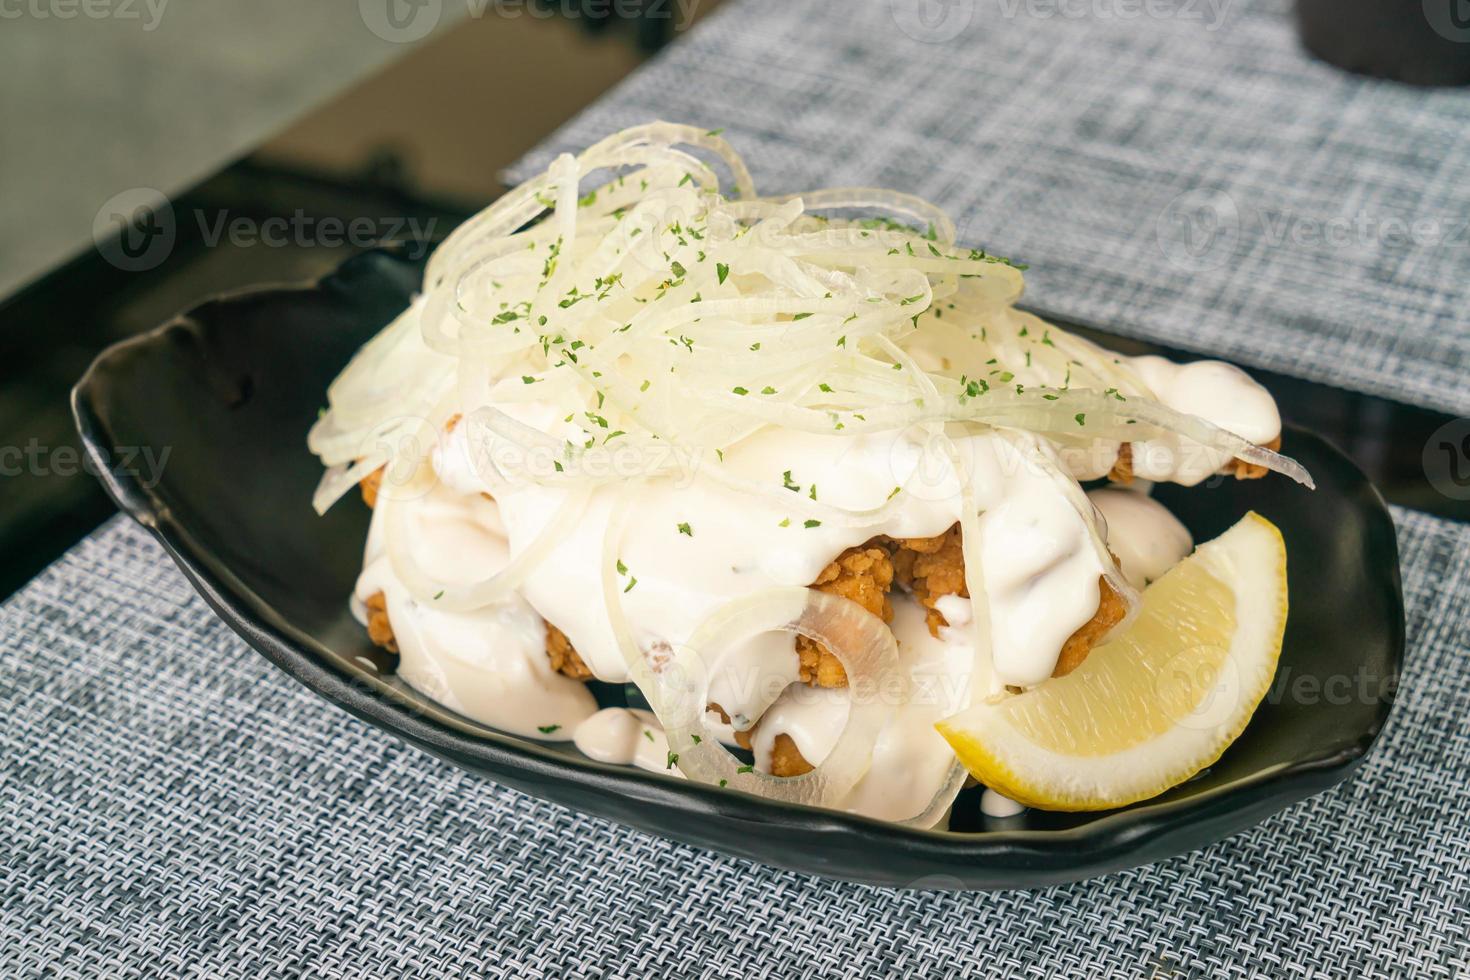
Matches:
[510,0,1470,414]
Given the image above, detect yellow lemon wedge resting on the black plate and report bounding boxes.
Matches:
[935,511,1286,810]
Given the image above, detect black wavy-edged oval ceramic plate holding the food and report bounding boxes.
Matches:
[74,251,1404,887]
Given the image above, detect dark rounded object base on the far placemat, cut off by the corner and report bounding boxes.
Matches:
[1297,0,1470,85]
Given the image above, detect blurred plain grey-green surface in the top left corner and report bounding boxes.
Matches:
[0,0,463,297]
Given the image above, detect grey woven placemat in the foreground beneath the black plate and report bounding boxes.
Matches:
[0,511,1470,980]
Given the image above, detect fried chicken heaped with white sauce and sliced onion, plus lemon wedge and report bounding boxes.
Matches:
[310,123,1311,827]
